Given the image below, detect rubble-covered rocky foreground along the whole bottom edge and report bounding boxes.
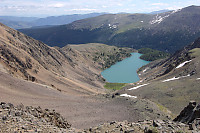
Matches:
[0,102,200,133]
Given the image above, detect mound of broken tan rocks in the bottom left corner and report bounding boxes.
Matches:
[0,102,71,132]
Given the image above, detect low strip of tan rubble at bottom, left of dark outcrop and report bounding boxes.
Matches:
[84,120,192,133]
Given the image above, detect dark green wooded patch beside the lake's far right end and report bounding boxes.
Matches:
[138,48,170,61]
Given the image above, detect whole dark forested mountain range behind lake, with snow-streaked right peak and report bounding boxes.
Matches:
[20,6,200,53]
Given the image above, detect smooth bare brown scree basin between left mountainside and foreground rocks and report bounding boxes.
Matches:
[0,72,166,128]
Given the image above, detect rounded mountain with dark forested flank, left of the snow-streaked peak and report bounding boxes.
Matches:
[20,14,153,47]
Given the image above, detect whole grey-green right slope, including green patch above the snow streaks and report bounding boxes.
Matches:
[125,48,200,115]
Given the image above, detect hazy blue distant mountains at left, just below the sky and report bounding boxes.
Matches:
[0,13,105,29]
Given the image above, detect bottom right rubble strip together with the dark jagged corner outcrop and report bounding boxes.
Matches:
[85,101,200,133]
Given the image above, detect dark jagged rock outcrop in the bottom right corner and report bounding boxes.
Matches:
[174,101,200,129]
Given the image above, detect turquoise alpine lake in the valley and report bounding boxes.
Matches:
[101,53,149,83]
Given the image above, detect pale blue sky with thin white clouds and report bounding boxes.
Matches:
[0,0,200,17]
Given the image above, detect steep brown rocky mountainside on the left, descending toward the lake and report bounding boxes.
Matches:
[0,24,134,93]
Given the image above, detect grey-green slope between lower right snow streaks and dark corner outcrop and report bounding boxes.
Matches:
[131,78,200,114]
